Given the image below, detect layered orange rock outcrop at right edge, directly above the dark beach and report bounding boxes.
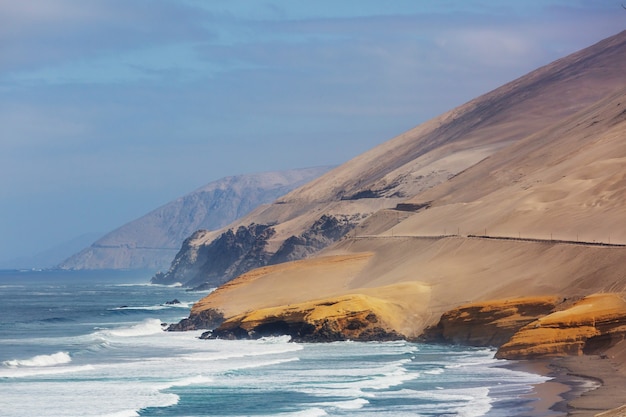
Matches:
[496,294,626,359]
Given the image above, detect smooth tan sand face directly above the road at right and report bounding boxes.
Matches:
[396,90,626,243]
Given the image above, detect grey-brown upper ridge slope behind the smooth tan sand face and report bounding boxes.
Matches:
[186,32,626,254]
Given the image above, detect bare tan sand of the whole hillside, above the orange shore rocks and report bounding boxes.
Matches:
[186,32,626,414]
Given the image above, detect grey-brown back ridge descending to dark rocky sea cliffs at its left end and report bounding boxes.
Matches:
[158,32,626,286]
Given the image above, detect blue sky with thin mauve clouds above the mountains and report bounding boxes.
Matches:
[0,0,626,265]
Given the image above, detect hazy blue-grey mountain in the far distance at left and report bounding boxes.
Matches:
[59,167,330,270]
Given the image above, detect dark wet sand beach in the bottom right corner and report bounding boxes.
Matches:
[516,355,626,417]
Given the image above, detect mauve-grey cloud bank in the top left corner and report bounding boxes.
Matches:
[0,0,215,72]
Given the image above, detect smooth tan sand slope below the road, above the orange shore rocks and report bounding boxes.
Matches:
[192,237,626,336]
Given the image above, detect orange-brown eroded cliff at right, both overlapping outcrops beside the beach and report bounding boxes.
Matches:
[424,293,626,359]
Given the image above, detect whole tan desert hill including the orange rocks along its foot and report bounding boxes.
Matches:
[182,28,626,360]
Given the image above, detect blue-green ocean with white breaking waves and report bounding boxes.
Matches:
[0,271,546,417]
